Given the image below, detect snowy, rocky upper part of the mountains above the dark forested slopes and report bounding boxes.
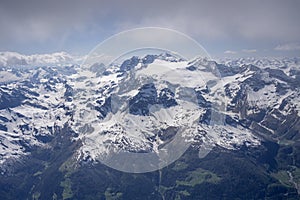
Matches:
[0,52,300,169]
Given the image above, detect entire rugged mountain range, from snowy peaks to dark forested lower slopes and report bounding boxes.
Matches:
[0,52,300,199]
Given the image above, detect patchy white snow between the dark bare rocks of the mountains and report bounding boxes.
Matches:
[0,52,300,165]
